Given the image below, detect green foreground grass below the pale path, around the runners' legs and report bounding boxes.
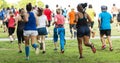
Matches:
[0,39,120,63]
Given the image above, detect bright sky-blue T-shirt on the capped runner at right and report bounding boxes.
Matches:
[99,11,112,30]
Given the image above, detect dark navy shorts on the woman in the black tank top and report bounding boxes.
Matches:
[77,26,90,37]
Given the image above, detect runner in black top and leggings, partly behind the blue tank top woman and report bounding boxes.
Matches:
[17,9,25,53]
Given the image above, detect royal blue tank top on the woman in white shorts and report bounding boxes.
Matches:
[24,12,37,30]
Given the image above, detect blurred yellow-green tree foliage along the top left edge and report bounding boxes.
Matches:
[0,0,44,9]
